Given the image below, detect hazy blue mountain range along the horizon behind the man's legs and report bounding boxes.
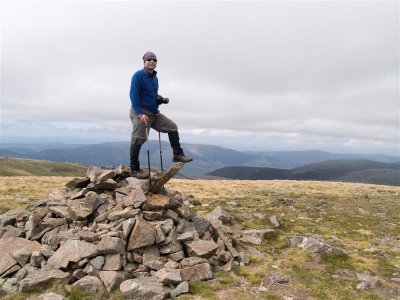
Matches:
[0,141,400,176]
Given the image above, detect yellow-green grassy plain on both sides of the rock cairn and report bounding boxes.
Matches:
[0,177,400,299]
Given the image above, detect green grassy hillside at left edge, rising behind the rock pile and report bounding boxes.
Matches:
[0,157,87,176]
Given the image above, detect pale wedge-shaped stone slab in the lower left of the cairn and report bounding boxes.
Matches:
[47,240,97,269]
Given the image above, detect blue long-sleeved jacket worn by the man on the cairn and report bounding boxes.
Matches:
[129,69,159,116]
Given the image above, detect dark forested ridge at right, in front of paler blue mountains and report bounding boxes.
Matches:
[207,159,400,186]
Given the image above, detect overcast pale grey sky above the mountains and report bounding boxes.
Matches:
[1,0,400,155]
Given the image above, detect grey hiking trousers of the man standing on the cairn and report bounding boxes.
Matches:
[129,108,178,146]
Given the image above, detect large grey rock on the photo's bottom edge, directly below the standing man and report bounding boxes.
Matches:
[120,277,169,300]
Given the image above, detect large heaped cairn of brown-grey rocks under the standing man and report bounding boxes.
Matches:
[0,166,242,299]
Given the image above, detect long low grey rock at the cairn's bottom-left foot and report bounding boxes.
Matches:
[18,269,70,291]
